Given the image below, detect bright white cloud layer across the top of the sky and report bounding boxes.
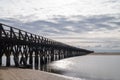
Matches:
[0,0,120,19]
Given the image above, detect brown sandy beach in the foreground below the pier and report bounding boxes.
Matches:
[0,67,80,80]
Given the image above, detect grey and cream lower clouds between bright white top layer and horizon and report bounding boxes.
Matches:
[0,14,120,50]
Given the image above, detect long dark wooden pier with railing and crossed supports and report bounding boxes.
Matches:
[0,23,93,67]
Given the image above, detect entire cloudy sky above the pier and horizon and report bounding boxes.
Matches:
[0,0,120,52]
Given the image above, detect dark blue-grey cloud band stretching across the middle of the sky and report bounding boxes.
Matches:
[0,15,120,34]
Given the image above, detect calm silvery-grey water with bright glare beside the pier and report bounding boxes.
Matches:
[49,55,120,80]
